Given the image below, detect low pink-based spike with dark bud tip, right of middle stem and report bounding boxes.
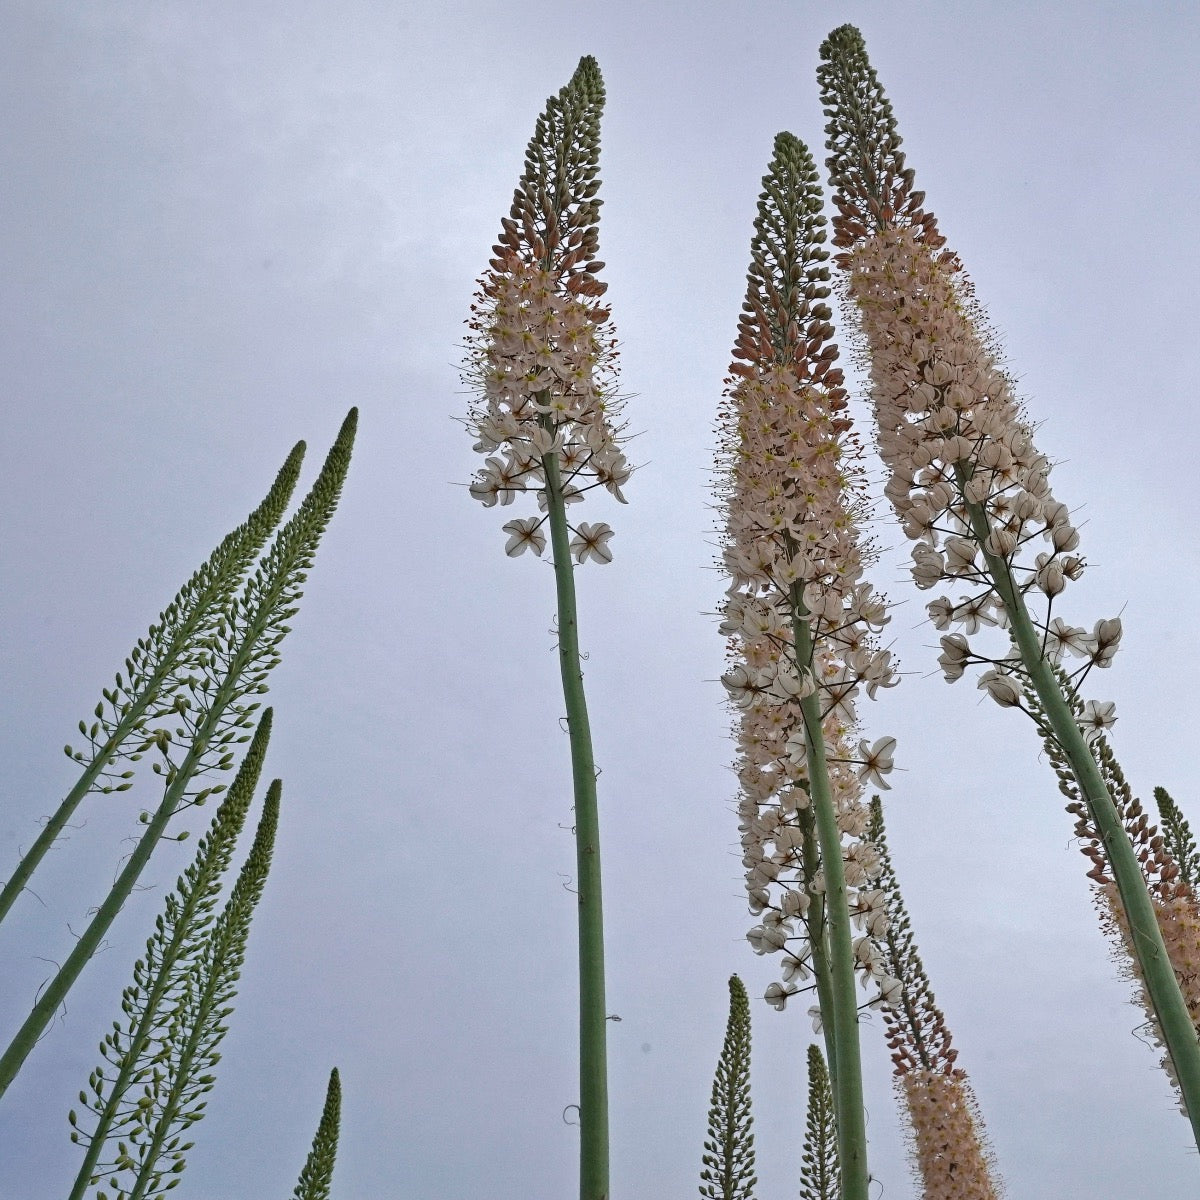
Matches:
[870,797,1001,1200]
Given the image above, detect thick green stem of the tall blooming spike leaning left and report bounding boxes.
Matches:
[967,504,1200,1147]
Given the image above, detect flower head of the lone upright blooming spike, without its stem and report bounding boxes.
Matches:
[463,58,632,563]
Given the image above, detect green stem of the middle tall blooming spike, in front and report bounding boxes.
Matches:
[792,604,869,1200]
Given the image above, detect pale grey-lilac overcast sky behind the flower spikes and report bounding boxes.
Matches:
[0,0,1200,1200]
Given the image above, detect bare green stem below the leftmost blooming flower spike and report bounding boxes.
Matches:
[542,454,608,1200]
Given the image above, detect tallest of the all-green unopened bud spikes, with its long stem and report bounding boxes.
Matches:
[0,408,358,1094]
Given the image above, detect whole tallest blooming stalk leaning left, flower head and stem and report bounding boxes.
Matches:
[818,25,1200,1145]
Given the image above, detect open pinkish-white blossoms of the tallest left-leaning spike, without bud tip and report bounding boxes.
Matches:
[848,228,1121,700]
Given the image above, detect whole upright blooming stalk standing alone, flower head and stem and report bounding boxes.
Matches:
[464,58,631,1200]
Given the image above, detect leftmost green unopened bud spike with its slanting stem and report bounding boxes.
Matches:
[0,442,305,920]
